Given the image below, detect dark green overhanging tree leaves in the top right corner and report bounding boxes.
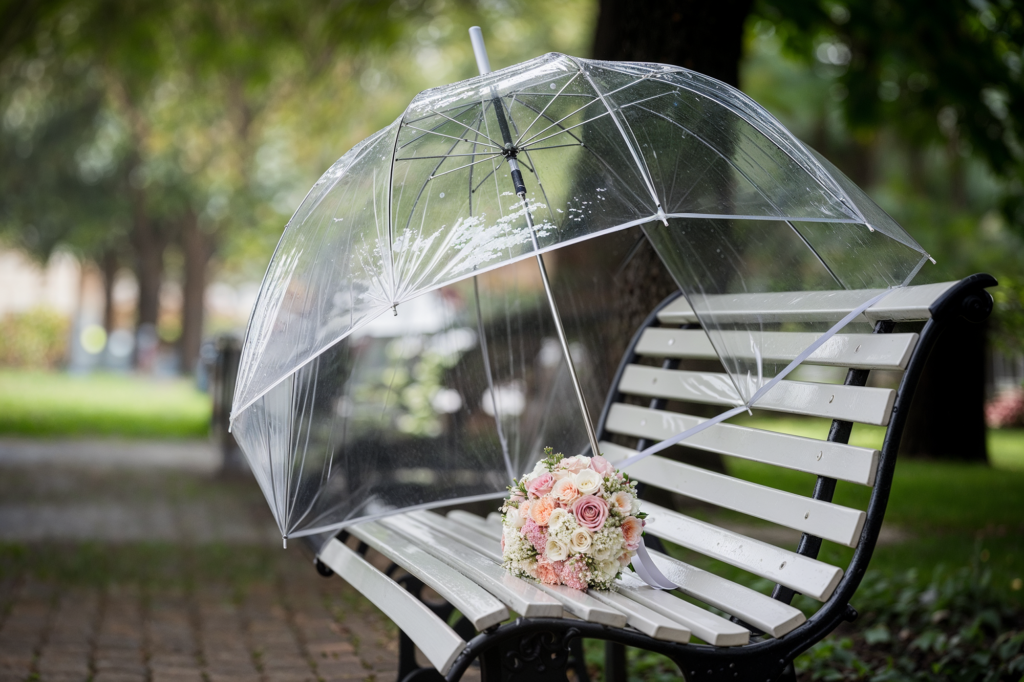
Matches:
[757,0,1024,220]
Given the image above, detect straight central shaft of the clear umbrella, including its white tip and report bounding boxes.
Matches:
[469,26,601,462]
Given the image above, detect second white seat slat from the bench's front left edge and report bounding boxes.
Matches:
[380,516,562,619]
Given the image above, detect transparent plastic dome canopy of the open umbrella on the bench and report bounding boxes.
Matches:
[231,45,929,538]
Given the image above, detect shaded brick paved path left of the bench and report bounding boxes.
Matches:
[0,446,413,682]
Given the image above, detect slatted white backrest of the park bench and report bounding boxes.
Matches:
[598,275,994,627]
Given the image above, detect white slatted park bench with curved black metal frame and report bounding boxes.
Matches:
[309,274,995,682]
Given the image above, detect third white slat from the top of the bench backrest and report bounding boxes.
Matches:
[618,365,896,426]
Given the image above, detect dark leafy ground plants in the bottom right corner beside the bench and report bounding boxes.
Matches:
[797,567,1024,682]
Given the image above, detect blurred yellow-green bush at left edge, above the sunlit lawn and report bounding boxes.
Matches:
[0,308,68,369]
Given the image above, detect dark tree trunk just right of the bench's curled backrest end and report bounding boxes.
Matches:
[900,323,988,464]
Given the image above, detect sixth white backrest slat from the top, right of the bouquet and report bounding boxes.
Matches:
[643,502,843,601]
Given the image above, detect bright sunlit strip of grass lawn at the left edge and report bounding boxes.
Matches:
[0,369,210,438]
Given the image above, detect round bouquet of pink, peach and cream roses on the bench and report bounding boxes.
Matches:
[502,447,647,590]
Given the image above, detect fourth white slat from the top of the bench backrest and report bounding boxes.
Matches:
[602,402,879,485]
